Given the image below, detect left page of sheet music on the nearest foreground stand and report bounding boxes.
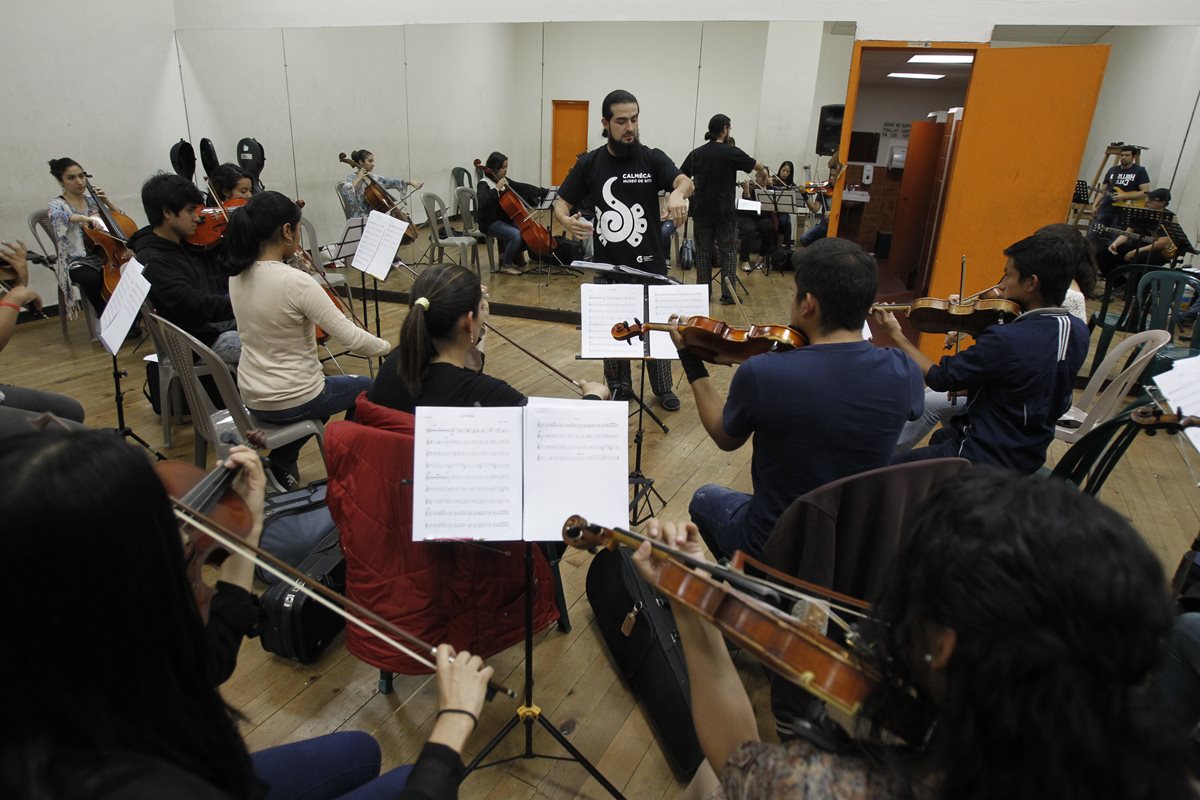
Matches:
[415,407,524,541]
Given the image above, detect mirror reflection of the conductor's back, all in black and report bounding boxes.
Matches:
[680,114,767,306]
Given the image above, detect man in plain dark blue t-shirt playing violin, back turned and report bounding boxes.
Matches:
[674,239,925,558]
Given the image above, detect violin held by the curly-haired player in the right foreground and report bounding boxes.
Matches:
[563,516,907,715]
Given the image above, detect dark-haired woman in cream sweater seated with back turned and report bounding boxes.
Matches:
[224,192,391,485]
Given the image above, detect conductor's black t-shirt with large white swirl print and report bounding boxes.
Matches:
[558,144,679,275]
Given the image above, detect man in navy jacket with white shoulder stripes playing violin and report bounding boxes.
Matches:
[875,234,1087,475]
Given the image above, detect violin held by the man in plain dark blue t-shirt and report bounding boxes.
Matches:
[612,317,809,363]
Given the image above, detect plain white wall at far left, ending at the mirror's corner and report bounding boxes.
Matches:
[0,0,187,305]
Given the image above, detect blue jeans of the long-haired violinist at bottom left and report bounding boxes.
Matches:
[250,730,413,800]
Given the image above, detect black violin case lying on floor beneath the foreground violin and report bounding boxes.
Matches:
[587,547,704,781]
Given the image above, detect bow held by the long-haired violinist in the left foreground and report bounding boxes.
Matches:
[172,500,517,699]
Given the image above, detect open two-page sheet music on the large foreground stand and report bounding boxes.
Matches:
[413,397,629,542]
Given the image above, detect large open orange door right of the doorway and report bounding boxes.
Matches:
[922,44,1109,357]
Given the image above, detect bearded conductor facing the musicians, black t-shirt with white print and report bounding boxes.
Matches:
[554,89,695,411]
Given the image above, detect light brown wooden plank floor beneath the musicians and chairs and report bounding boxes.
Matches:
[2,272,1200,798]
